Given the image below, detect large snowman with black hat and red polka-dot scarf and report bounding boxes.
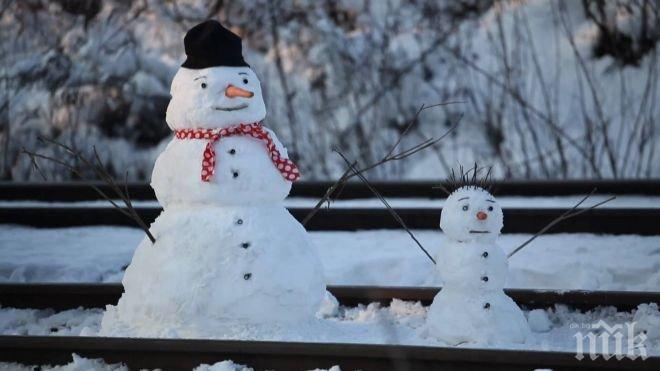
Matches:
[101,21,326,337]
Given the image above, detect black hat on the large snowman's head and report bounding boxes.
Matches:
[181,20,250,70]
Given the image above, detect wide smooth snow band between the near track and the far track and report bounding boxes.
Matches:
[0,225,660,291]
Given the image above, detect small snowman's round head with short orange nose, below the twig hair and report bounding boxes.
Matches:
[440,186,504,242]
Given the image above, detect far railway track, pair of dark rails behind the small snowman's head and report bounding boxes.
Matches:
[0,180,660,235]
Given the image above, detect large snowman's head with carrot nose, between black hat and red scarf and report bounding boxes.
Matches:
[166,66,266,130]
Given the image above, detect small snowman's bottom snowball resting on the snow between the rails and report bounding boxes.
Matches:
[425,288,530,345]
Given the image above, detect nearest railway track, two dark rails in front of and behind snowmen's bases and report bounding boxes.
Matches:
[0,284,660,371]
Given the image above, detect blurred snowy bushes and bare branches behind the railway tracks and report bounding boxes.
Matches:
[0,0,660,180]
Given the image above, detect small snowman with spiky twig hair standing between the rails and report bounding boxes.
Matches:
[424,171,530,345]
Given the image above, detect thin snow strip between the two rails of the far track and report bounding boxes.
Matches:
[0,195,660,209]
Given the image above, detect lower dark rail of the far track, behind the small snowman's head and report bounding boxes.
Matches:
[0,207,660,235]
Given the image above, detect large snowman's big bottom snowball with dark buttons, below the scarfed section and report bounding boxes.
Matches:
[100,204,326,338]
